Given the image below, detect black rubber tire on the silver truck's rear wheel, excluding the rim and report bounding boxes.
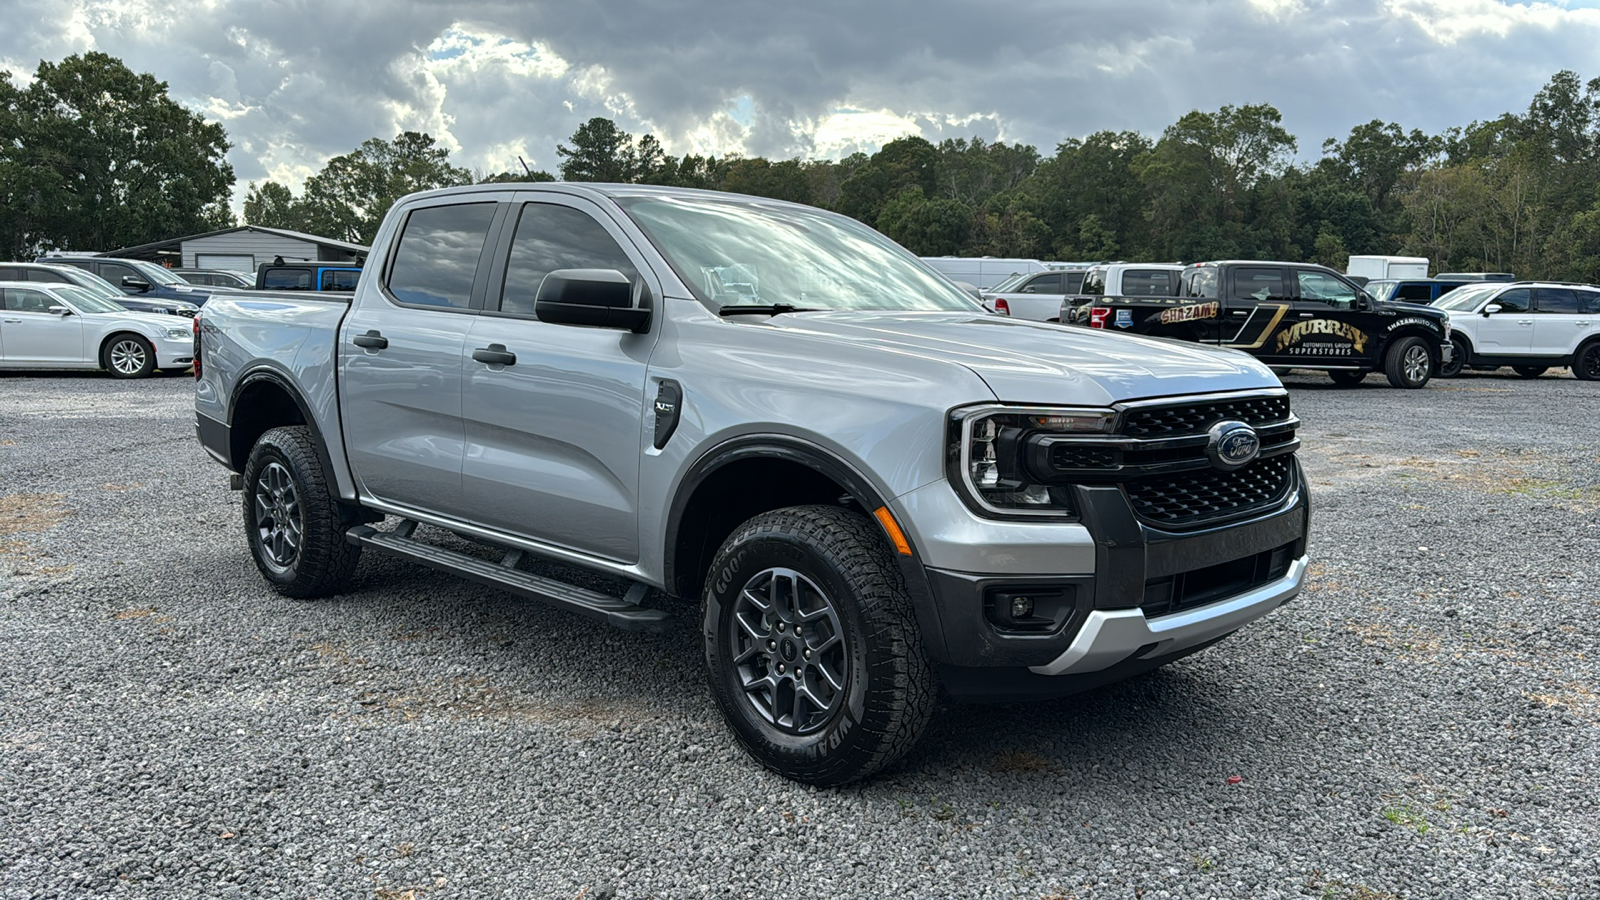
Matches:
[243,424,362,599]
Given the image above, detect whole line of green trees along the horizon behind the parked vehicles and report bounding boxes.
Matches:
[0,53,1600,282]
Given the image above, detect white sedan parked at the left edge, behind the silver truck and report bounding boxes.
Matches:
[0,282,194,378]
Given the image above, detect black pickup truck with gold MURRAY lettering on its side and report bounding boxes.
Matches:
[1078,259,1451,388]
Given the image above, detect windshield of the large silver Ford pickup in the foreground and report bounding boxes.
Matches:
[618,197,981,312]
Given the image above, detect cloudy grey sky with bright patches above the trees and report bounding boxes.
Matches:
[0,0,1600,204]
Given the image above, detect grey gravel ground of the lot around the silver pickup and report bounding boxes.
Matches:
[0,373,1600,900]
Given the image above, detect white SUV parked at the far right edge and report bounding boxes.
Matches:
[1434,282,1600,381]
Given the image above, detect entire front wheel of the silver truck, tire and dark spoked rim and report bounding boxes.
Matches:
[701,506,934,786]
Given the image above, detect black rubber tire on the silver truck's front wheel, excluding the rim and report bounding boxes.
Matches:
[701,506,936,786]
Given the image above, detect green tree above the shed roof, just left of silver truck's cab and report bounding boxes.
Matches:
[301,131,472,243]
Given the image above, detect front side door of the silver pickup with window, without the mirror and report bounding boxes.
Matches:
[462,199,661,562]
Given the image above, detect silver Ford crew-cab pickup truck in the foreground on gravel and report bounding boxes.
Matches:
[195,183,1309,785]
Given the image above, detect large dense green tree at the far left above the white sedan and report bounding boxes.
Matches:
[0,53,234,255]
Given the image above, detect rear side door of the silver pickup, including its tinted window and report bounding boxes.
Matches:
[339,197,502,517]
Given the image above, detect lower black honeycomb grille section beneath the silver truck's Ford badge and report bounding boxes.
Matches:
[1125,453,1294,528]
